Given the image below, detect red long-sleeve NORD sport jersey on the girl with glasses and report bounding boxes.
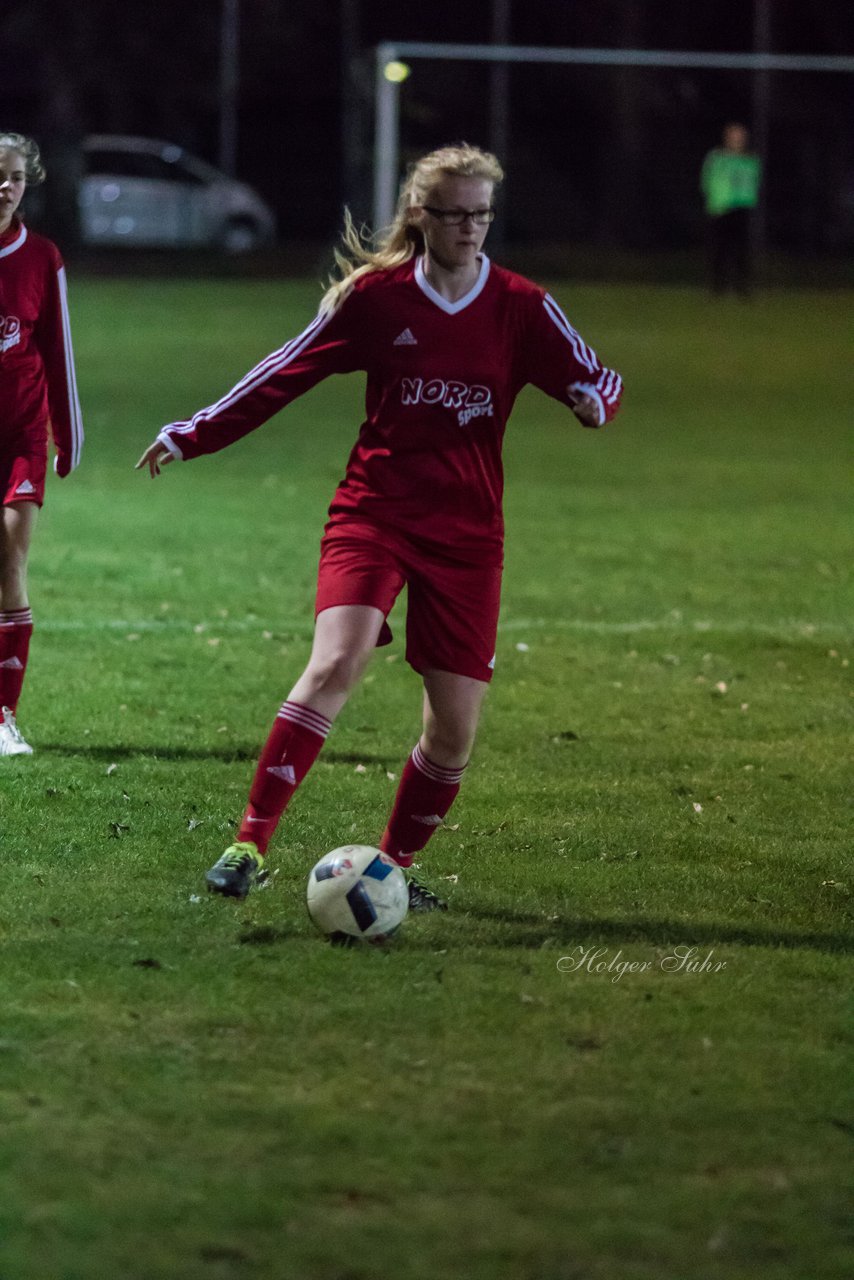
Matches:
[159,256,622,559]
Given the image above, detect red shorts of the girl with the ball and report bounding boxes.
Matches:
[315,520,502,682]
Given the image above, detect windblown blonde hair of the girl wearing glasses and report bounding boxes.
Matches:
[320,142,504,311]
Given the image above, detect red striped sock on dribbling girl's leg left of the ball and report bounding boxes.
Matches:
[237,703,332,854]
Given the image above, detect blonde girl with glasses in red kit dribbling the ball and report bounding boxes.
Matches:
[137,145,622,910]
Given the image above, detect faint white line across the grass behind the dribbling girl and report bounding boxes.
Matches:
[36,614,850,639]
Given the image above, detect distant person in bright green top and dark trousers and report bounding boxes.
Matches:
[700,124,762,297]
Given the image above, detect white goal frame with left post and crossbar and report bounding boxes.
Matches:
[374,41,854,230]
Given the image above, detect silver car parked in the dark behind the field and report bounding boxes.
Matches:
[79,134,275,253]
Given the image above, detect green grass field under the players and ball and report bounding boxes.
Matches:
[0,279,854,1280]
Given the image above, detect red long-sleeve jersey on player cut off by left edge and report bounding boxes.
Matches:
[0,218,83,476]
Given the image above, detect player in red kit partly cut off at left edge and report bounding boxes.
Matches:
[0,132,83,756]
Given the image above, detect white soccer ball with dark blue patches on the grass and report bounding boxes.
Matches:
[307,845,410,942]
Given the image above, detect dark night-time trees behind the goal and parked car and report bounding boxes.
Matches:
[0,0,854,253]
